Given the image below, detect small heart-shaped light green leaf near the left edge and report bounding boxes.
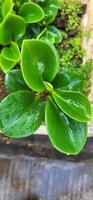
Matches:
[1,42,20,62]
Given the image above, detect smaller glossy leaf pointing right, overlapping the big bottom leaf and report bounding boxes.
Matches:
[52,90,92,122]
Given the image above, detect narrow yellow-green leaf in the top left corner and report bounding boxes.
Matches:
[2,0,14,18]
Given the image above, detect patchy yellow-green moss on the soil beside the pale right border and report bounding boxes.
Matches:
[57,0,92,95]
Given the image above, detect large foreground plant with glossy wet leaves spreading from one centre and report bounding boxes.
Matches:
[0,39,92,154]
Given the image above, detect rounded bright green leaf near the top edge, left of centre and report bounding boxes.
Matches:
[19,2,44,23]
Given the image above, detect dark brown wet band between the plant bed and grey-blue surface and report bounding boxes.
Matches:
[0,135,93,162]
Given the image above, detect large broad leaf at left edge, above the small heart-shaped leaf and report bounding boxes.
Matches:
[0,13,26,45]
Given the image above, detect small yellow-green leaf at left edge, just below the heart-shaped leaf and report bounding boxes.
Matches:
[0,54,16,73]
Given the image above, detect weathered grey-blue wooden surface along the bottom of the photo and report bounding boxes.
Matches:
[0,149,93,200]
